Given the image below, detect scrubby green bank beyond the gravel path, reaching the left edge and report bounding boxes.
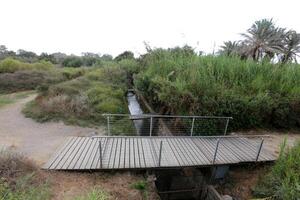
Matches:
[0,58,88,94]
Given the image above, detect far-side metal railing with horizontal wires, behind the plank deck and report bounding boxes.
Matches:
[103,114,232,136]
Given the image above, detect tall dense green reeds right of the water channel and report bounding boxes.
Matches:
[135,48,300,130]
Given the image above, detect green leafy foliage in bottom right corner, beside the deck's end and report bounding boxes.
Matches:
[254,140,300,200]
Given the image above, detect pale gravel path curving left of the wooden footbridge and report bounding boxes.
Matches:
[0,95,103,165]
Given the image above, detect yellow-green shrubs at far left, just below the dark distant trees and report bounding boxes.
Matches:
[0,58,53,73]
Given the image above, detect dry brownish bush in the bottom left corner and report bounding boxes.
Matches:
[0,151,50,200]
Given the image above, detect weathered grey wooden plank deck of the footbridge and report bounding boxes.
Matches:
[43,136,276,170]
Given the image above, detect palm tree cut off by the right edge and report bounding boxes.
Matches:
[281,30,300,63]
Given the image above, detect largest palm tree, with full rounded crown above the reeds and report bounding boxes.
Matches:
[242,19,285,60]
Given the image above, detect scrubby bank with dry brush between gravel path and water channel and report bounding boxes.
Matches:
[24,66,128,126]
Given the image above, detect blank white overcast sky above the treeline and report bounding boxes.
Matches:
[0,0,300,56]
